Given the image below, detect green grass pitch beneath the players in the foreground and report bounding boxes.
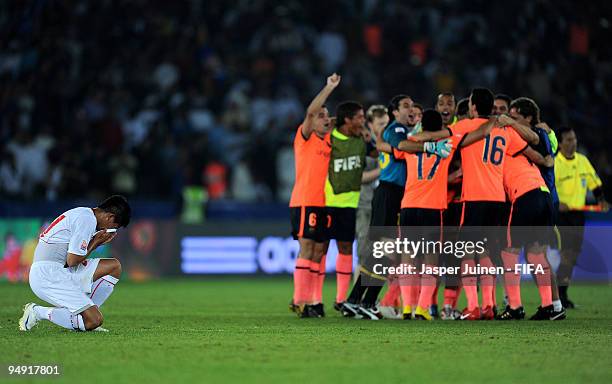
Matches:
[0,277,612,384]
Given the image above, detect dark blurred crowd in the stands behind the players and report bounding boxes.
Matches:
[0,0,612,201]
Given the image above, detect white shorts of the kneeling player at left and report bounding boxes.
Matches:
[30,259,100,314]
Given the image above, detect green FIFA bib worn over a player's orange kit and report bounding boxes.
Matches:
[325,129,366,208]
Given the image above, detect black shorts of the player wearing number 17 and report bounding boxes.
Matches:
[400,208,443,241]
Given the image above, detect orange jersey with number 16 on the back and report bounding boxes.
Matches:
[451,118,527,202]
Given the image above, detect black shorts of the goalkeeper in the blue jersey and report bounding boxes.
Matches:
[370,181,404,240]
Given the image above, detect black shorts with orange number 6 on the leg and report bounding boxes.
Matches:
[289,207,330,243]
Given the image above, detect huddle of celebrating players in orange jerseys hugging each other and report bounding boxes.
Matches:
[290,74,603,320]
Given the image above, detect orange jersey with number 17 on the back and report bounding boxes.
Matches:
[393,138,459,209]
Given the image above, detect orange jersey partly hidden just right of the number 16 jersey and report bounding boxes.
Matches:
[504,153,548,203]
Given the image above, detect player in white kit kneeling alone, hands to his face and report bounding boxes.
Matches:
[19,195,131,331]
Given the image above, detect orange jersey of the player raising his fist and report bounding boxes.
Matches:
[289,125,331,207]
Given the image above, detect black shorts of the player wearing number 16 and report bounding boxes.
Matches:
[460,201,508,243]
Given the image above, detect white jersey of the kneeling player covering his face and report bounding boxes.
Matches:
[33,207,97,264]
